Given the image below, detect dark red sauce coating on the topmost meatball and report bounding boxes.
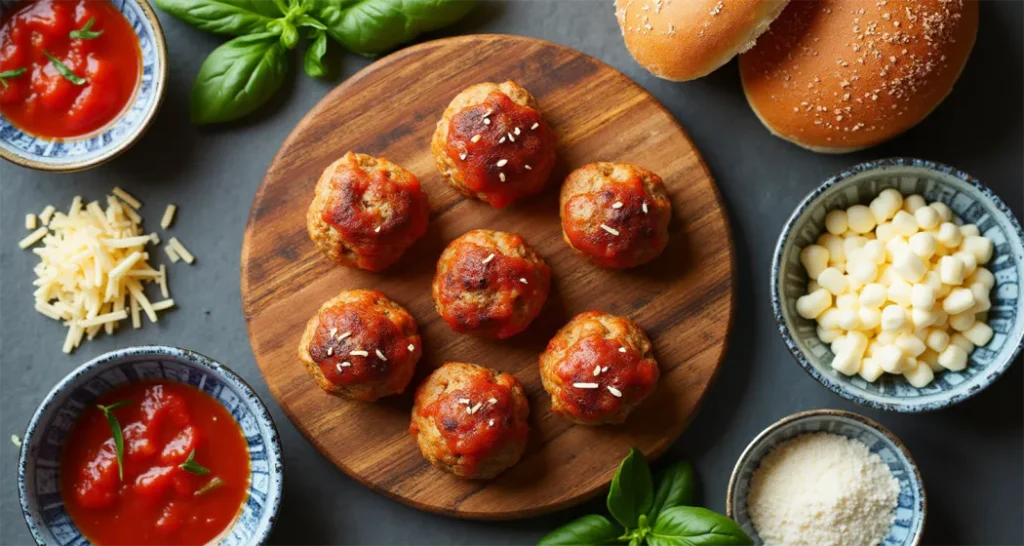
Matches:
[445,91,555,208]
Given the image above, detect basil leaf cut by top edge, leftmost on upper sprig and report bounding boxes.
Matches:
[156,0,284,36]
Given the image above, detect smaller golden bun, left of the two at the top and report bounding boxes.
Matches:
[615,0,790,81]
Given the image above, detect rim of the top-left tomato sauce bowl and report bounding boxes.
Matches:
[0,0,167,172]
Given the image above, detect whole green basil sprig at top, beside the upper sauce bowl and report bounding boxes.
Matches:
[156,0,476,124]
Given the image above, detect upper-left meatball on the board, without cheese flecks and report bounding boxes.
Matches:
[306,152,430,271]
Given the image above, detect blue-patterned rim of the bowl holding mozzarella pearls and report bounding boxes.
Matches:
[771,158,1024,413]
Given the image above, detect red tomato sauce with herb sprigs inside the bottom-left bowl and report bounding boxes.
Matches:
[60,380,250,546]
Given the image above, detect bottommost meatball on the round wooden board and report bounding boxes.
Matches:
[409,362,529,479]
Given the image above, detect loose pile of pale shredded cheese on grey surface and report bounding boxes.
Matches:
[18,187,194,353]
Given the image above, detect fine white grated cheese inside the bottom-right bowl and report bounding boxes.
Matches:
[746,432,899,546]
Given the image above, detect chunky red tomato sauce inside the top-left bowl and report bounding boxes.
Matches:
[0,0,142,138]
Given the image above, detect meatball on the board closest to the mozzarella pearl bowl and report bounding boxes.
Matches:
[560,163,672,268]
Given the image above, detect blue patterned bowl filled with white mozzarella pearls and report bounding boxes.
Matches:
[771,159,1024,412]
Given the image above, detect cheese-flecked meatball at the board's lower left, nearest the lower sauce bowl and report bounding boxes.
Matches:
[299,290,422,402]
